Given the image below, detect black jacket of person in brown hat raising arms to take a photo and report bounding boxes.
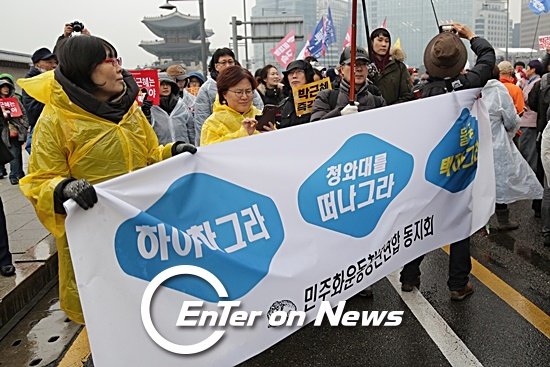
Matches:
[422,37,496,98]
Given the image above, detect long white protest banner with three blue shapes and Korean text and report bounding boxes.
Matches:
[67,91,495,367]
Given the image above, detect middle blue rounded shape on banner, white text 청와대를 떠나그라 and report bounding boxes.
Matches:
[298,134,414,238]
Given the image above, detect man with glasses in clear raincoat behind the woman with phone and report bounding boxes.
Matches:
[195,47,264,145]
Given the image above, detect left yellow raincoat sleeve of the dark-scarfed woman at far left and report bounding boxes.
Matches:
[19,113,71,238]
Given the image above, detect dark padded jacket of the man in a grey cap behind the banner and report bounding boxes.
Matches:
[311,79,386,121]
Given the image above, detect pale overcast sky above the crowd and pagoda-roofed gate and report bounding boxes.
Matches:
[0,0,521,68]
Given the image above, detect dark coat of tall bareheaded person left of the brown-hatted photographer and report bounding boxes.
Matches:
[374,60,413,105]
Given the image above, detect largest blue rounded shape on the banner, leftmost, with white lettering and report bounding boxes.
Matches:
[115,173,284,302]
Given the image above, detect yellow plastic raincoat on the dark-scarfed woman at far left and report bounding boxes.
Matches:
[17,71,172,323]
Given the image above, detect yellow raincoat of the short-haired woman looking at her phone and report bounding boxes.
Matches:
[201,101,262,146]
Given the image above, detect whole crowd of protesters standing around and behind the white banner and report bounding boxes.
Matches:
[0,23,550,330]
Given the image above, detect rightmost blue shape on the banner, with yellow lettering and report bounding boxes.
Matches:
[425,108,479,193]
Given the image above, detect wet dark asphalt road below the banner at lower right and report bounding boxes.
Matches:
[241,202,550,367]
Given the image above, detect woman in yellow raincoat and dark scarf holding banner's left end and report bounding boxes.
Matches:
[18,35,196,323]
